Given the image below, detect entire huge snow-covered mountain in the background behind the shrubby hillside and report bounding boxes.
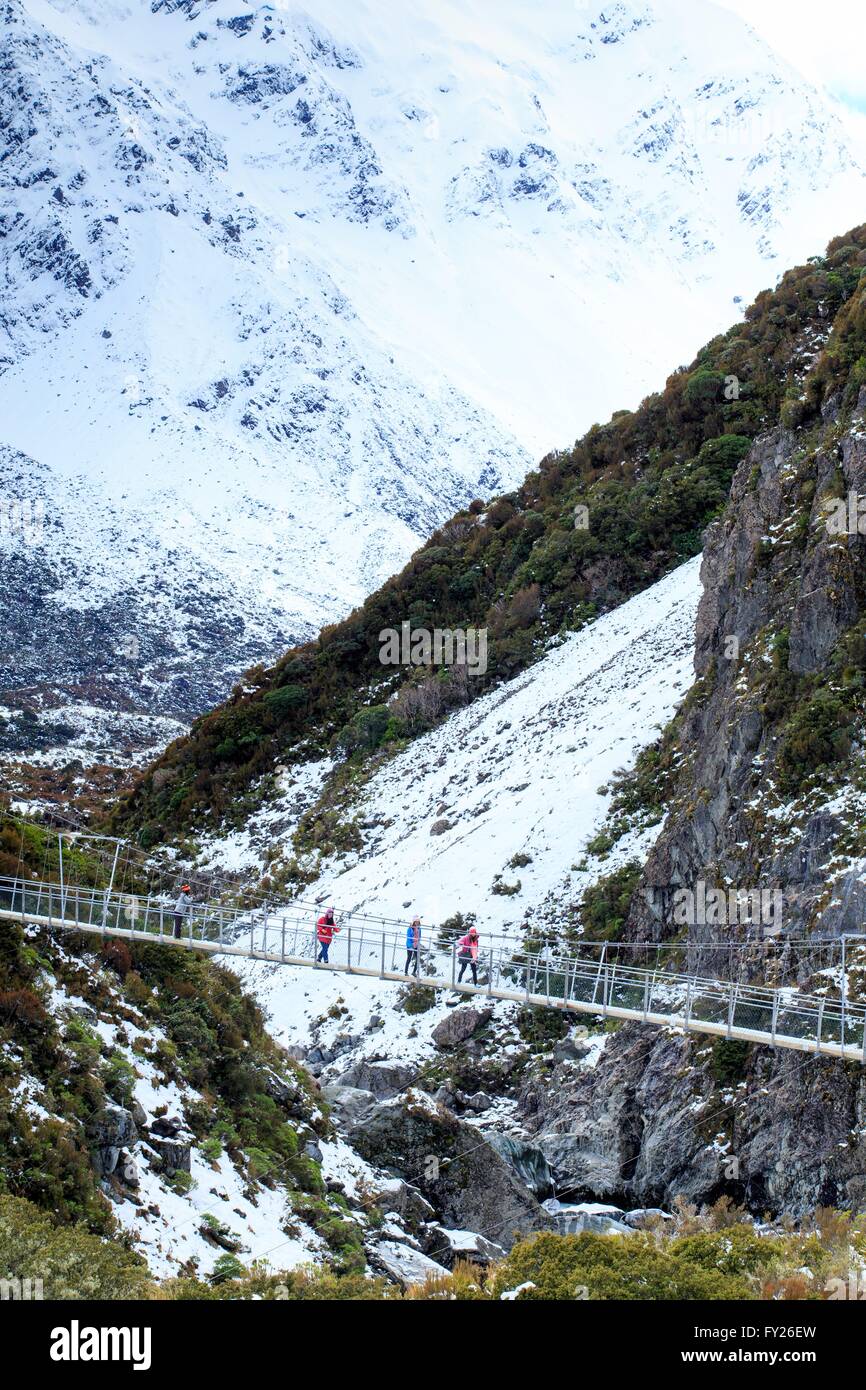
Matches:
[0,0,866,751]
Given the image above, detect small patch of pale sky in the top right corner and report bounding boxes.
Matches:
[716,0,866,113]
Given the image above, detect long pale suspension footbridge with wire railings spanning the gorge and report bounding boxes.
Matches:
[0,877,866,1063]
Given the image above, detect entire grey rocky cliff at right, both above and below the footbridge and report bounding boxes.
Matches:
[521,384,866,1215]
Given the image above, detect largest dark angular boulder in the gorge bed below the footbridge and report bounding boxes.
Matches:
[349,1091,550,1250]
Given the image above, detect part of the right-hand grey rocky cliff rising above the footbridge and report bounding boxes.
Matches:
[631,396,866,938]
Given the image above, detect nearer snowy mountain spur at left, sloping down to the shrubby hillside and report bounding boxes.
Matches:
[0,0,528,750]
